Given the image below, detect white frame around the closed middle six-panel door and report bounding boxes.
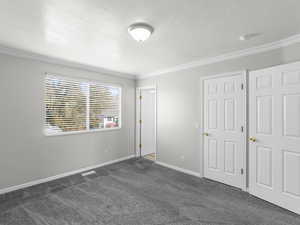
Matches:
[200,70,249,192]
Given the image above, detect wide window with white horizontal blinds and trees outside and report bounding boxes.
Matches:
[44,75,121,135]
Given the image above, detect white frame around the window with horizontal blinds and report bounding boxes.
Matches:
[43,73,123,137]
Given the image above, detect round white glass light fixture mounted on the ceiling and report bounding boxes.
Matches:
[128,23,154,42]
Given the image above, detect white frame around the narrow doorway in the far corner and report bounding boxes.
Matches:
[135,85,158,161]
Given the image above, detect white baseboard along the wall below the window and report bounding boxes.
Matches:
[0,155,135,195]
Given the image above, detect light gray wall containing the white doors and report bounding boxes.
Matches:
[137,44,300,176]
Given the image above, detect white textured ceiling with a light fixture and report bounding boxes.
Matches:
[0,0,300,75]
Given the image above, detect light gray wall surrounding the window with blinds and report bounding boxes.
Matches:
[0,54,135,189]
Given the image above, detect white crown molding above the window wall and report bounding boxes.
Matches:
[0,45,137,80]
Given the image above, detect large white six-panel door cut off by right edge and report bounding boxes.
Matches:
[249,63,300,214]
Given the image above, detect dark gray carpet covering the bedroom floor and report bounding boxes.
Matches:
[0,160,300,225]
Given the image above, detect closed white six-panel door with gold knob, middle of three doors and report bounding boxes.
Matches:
[204,72,246,189]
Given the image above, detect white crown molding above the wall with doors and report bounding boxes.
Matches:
[137,34,300,79]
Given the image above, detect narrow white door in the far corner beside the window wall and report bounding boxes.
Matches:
[140,88,156,156]
